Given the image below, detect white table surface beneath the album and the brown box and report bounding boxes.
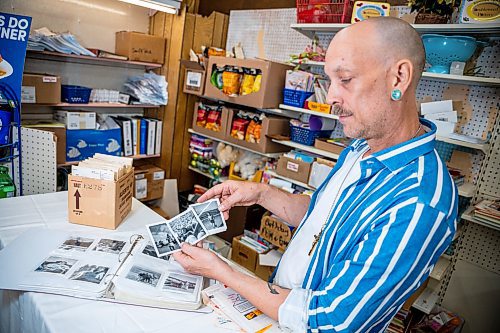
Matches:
[0,192,228,333]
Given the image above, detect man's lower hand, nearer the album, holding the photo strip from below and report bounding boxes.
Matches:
[172,243,232,280]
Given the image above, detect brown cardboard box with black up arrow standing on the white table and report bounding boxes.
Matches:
[68,169,134,229]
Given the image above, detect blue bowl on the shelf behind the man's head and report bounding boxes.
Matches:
[422,34,478,74]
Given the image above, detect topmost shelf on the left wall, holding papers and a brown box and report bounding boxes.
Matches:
[26,50,163,69]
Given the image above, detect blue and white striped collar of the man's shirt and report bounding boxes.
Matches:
[350,118,437,172]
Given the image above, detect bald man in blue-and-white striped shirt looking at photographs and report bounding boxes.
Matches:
[174,17,457,332]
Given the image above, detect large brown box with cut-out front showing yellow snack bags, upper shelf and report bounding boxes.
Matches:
[205,57,291,109]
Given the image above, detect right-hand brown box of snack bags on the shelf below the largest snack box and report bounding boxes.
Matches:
[225,109,290,153]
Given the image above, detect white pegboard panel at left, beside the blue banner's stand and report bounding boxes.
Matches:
[21,127,57,195]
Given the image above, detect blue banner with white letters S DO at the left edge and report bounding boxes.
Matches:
[0,12,31,145]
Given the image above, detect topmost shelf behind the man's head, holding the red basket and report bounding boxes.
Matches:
[290,23,498,38]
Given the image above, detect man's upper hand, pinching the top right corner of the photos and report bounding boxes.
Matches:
[198,180,268,220]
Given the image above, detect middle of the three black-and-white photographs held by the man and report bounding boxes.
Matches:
[167,208,207,244]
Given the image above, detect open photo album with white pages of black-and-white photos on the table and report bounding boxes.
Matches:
[0,228,211,312]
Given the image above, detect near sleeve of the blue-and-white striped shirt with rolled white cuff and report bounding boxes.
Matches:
[279,202,456,332]
